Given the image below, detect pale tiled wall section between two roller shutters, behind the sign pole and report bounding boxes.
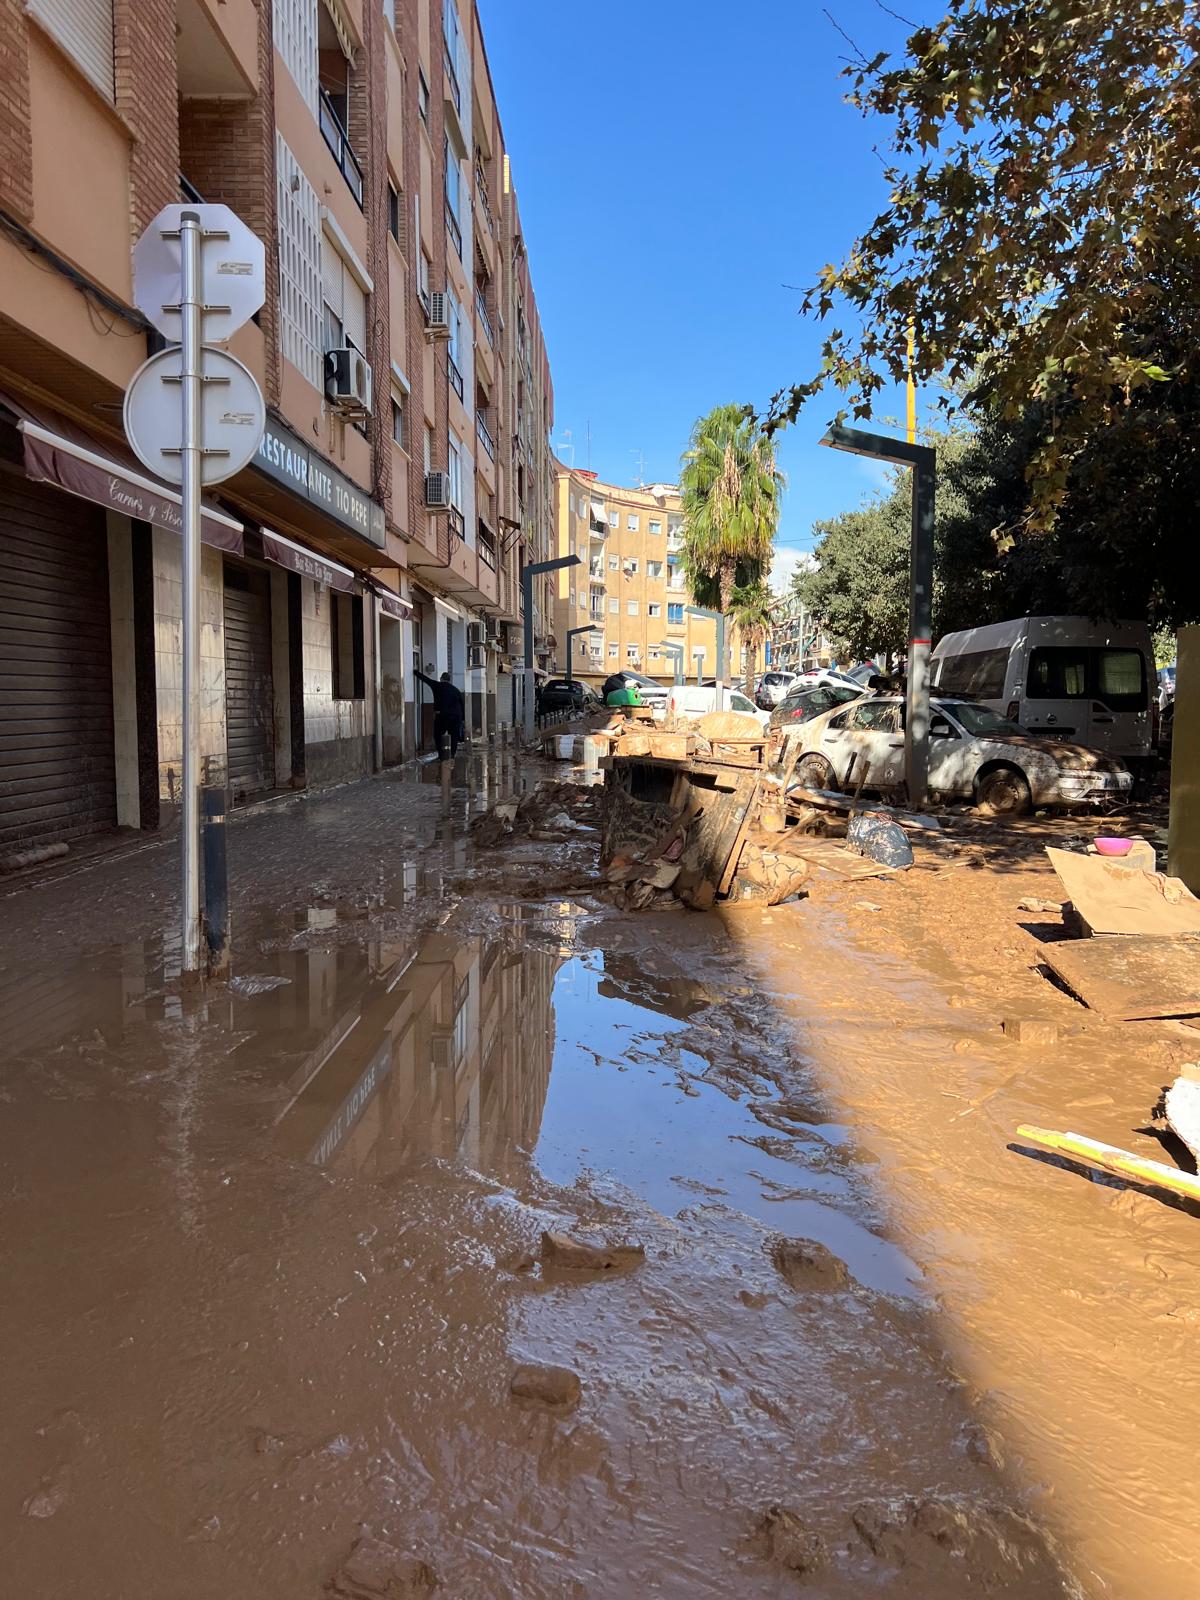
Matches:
[154,528,226,805]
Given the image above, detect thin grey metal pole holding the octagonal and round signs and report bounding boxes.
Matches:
[179,211,203,973]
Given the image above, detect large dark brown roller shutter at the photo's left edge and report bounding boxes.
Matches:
[0,472,117,853]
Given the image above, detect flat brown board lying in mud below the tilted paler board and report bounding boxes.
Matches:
[1042,936,1200,1022]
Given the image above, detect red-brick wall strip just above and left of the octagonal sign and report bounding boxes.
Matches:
[114,0,179,240]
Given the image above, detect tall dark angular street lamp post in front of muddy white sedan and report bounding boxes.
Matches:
[821,426,938,806]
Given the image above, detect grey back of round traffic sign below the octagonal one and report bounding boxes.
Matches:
[125,346,267,485]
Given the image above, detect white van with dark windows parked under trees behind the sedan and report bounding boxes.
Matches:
[930,616,1155,758]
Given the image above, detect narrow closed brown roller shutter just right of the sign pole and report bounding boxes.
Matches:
[224,563,275,805]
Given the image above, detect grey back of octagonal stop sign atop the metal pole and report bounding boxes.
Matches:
[133,205,267,344]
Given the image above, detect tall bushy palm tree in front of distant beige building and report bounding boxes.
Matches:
[680,405,784,674]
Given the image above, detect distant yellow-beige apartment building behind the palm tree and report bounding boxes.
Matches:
[554,462,771,688]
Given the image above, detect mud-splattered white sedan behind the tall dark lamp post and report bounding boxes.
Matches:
[795,694,1133,816]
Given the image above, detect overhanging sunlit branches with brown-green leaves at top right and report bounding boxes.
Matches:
[768,0,1200,530]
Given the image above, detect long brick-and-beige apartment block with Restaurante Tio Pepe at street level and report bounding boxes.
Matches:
[0,0,554,851]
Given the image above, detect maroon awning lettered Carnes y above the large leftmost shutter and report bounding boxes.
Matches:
[0,390,243,555]
